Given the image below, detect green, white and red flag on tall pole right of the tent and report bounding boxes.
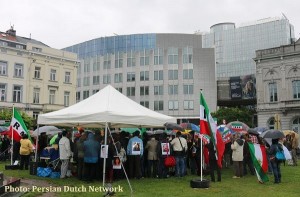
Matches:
[200,93,225,168]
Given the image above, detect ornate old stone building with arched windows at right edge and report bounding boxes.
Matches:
[254,40,300,133]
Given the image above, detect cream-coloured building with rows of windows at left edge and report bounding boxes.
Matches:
[0,28,78,118]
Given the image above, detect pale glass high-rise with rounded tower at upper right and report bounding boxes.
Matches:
[202,16,295,79]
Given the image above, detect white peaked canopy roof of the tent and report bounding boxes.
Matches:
[38,85,176,128]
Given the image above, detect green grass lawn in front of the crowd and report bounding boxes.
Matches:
[0,163,300,197]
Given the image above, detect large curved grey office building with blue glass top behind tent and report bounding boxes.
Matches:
[64,34,217,118]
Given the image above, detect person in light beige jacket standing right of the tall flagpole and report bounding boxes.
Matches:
[231,134,244,179]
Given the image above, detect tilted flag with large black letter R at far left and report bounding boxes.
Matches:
[8,108,32,142]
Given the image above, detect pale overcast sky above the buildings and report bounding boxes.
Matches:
[0,0,300,49]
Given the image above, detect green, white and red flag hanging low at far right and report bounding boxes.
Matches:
[248,142,269,183]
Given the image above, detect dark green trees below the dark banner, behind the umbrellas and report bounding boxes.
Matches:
[212,107,255,127]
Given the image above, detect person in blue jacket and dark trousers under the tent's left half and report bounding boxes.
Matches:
[83,133,100,181]
